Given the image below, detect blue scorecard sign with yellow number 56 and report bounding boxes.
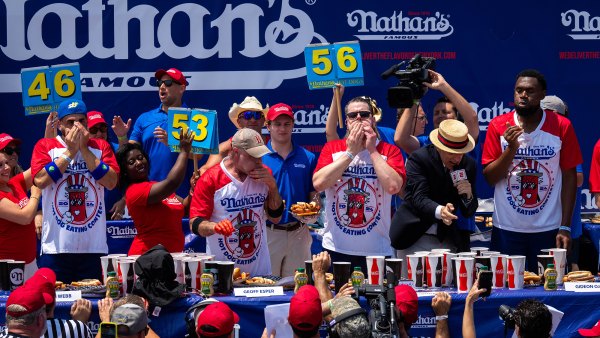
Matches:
[304,42,365,90]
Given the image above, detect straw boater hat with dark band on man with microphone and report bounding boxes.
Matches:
[429,120,475,154]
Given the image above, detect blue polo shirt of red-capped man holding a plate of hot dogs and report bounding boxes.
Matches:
[262,140,317,224]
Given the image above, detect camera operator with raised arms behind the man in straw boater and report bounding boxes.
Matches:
[394,70,479,155]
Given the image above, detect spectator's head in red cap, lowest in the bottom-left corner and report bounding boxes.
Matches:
[6,286,46,337]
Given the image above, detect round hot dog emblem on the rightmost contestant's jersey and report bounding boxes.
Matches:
[508,159,551,209]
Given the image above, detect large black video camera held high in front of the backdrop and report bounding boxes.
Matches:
[381,54,435,108]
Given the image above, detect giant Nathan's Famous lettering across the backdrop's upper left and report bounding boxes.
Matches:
[0,0,327,92]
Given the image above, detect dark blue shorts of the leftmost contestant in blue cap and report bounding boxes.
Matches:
[38,253,104,283]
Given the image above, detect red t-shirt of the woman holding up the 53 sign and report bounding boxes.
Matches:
[125,182,184,255]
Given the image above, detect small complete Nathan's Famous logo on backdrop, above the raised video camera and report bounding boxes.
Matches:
[346,9,454,40]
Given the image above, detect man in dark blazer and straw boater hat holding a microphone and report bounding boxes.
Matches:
[390,120,478,259]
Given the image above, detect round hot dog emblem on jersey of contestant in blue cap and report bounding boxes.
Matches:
[54,174,99,226]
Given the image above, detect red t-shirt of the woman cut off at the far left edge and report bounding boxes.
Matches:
[0,173,36,263]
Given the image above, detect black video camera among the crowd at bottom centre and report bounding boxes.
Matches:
[353,272,404,338]
